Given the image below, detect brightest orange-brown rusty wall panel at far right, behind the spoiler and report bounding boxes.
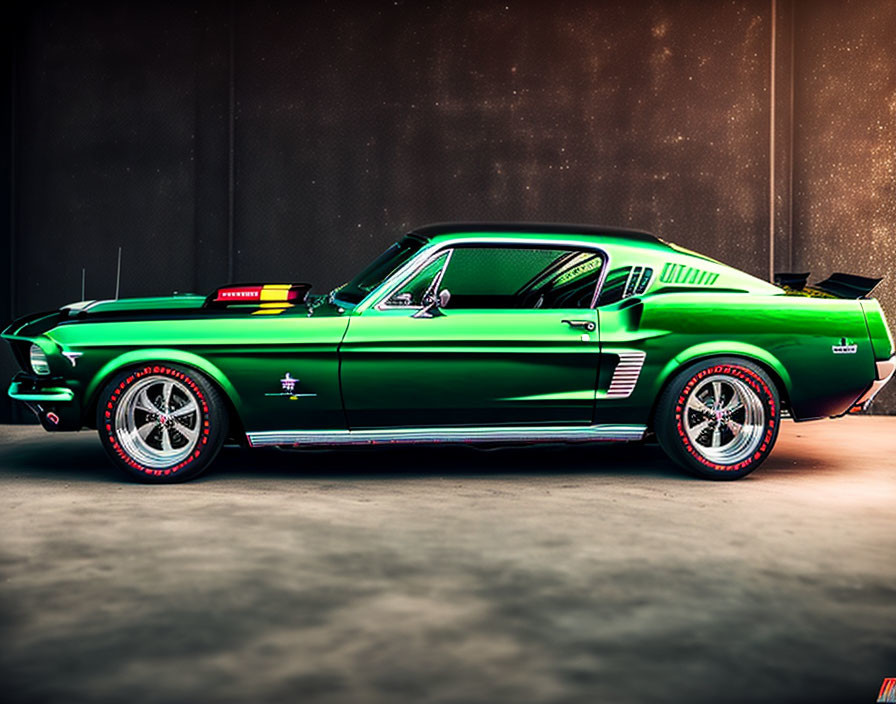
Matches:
[793,0,896,413]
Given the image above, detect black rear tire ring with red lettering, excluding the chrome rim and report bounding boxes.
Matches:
[655,357,781,480]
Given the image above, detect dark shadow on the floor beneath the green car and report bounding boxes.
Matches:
[0,433,838,482]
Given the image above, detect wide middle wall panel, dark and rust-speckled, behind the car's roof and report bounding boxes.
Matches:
[235,1,770,288]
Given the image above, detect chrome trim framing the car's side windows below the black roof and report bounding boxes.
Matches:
[355,237,611,314]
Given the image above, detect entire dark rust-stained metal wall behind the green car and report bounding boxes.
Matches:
[0,0,896,419]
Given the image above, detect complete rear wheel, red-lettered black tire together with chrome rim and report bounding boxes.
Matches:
[654,357,781,480]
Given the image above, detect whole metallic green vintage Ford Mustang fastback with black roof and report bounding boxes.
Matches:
[2,223,896,482]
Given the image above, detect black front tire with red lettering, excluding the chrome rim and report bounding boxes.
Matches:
[96,362,227,483]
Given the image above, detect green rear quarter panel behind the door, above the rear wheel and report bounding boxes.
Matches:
[596,292,874,422]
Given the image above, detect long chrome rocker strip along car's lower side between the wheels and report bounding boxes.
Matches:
[246,425,647,447]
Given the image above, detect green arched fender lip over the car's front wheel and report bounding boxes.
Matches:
[83,348,245,438]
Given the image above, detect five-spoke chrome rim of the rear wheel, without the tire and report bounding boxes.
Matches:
[684,374,766,465]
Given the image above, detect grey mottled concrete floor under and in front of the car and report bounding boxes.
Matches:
[0,417,896,704]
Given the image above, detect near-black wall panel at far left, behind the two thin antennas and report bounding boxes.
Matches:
[14,3,203,313]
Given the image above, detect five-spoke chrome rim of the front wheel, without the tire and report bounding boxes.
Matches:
[115,376,201,469]
